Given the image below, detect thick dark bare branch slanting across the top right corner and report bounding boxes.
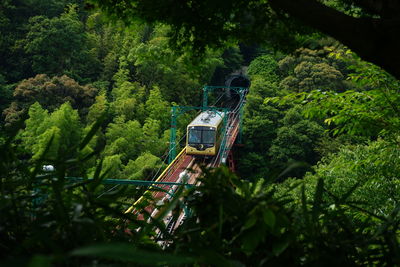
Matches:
[269,0,400,78]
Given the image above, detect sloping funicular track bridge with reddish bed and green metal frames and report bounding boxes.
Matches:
[126,80,248,232]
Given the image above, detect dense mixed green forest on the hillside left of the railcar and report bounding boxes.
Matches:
[0,1,224,179]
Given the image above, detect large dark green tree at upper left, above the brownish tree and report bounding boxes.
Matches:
[24,5,101,81]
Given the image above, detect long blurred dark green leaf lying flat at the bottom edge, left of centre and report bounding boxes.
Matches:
[70,243,195,266]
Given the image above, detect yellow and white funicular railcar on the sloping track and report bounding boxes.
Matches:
[186,110,224,157]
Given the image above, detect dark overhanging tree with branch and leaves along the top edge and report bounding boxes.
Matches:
[94,0,400,78]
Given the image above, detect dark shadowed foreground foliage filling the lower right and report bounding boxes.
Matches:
[173,168,399,266]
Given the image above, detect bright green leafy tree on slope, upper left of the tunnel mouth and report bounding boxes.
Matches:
[122,24,222,104]
